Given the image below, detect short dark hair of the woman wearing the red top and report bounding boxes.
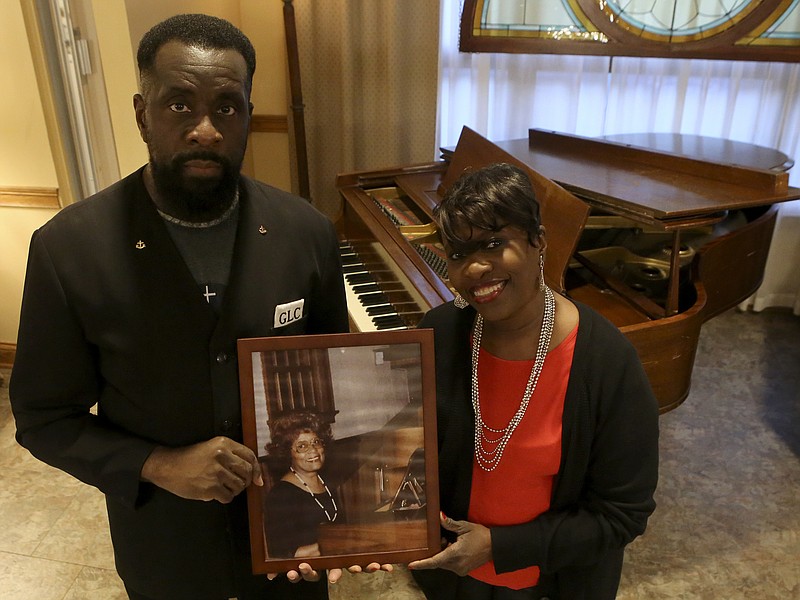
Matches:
[433,163,541,245]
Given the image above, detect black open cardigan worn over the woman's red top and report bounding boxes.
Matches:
[420,303,658,600]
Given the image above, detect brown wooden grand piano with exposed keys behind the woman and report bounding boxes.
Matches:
[336,128,800,413]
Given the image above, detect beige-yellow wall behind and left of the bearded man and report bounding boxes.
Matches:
[0,0,291,344]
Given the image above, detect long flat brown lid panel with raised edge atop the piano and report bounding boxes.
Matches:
[495,129,800,230]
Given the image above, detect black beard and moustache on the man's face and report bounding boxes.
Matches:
[150,150,241,221]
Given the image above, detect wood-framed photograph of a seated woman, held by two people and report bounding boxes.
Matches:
[238,329,440,573]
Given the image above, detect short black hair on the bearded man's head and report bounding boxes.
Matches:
[136,14,256,91]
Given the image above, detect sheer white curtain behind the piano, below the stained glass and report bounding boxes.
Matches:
[437,0,800,314]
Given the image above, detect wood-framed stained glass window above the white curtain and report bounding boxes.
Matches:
[461,0,800,62]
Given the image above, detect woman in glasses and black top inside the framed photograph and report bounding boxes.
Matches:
[265,412,339,558]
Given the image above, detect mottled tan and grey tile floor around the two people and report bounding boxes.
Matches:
[0,310,800,600]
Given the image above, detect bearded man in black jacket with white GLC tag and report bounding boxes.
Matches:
[10,15,347,600]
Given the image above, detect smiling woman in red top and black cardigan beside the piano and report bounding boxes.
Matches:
[409,164,658,600]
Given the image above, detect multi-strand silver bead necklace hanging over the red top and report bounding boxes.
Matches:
[472,287,556,471]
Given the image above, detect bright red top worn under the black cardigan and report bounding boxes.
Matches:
[468,326,578,590]
